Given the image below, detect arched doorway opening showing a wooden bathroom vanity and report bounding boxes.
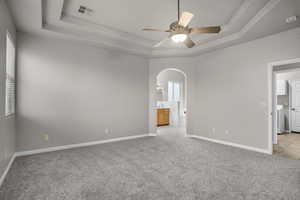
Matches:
[155,68,187,135]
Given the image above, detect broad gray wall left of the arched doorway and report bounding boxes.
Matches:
[17,33,149,151]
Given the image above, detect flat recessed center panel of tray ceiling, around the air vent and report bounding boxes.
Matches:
[64,0,243,41]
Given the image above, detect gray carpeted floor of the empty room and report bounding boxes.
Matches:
[0,129,300,200]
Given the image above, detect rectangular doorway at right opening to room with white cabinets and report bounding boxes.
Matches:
[272,57,300,160]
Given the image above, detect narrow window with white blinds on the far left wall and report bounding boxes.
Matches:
[5,32,16,116]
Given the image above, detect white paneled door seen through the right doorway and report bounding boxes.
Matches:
[290,81,300,132]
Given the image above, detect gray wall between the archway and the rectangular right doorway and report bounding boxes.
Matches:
[193,29,300,149]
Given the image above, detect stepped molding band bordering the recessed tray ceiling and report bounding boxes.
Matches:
[41,0,281,57]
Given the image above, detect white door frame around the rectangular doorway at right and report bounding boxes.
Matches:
[267,58,300,154]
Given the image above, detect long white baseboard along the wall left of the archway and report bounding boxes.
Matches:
[16,134,152,157]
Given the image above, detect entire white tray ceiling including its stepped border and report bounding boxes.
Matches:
[8,0,300,57]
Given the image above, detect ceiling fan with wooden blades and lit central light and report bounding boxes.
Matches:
[143,0,221,48]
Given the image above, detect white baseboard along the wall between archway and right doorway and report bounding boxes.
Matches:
[187,135,272,154]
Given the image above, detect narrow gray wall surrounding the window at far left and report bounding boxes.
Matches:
[0,0,15,177]
